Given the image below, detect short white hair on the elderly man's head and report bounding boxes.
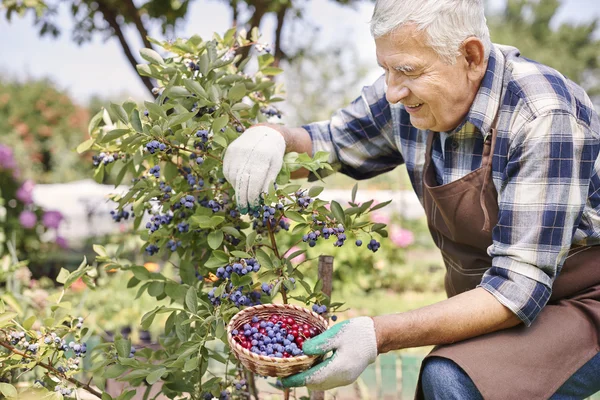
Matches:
[371,0,492,64]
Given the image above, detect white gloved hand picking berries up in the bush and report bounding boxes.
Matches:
[223,126,285,214]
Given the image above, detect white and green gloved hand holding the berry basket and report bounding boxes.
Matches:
[281,317,377,390]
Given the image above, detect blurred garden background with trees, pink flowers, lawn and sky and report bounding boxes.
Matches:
[0,0,600,399]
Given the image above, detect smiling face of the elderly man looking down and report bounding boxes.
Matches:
[375,25,480,132]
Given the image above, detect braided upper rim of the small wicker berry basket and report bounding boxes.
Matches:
[227,304,329,364]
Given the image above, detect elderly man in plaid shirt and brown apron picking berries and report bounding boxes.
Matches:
[224,0,600,399]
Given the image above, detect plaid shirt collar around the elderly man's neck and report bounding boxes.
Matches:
[450,44,505,135]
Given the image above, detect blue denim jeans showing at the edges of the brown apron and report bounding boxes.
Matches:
[421,353,600,400]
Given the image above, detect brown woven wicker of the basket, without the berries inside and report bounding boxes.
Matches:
[227,304,329,378]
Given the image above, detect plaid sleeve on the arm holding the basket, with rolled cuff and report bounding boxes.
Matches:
[480,111,598,326]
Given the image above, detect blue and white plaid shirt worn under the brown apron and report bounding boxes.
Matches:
[304,45,600,326]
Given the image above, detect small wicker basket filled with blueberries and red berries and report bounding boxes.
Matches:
[227,304,328,377]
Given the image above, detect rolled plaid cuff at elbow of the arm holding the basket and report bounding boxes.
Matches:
[478,267,552,326]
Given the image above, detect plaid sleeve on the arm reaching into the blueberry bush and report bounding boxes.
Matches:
[303,76,404,179]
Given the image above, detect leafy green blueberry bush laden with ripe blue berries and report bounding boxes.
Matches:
[0,30,387,400]
